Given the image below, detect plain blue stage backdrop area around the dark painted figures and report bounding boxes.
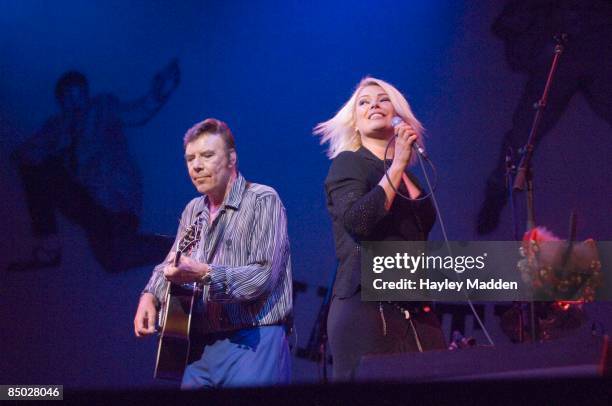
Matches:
[0,0,612,388]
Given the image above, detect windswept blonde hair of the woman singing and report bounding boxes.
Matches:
[313,76,424,164]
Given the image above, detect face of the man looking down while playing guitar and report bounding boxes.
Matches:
[185,134,236,199]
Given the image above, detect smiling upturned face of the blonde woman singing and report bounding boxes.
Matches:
[355,85,395,138]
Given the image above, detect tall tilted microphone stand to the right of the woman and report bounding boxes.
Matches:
[513,34,567,342]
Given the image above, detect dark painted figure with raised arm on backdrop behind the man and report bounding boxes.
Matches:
[9,60,180,272]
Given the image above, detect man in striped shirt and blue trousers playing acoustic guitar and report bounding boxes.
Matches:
[134,118,292,389]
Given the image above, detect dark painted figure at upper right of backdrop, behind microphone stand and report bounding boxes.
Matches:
[477,0,612,234]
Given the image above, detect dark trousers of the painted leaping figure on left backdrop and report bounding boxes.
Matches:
[19,159,172,272]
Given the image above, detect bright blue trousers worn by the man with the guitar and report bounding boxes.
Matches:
[181,326,291,389]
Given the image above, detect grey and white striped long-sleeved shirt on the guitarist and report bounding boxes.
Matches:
[143,174,293,333]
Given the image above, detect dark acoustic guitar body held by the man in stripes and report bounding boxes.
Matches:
[154,283,198,381]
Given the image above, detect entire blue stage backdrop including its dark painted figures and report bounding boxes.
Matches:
[0,0,612,388]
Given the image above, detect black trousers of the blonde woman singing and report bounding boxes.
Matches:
[327,292,446,381]
